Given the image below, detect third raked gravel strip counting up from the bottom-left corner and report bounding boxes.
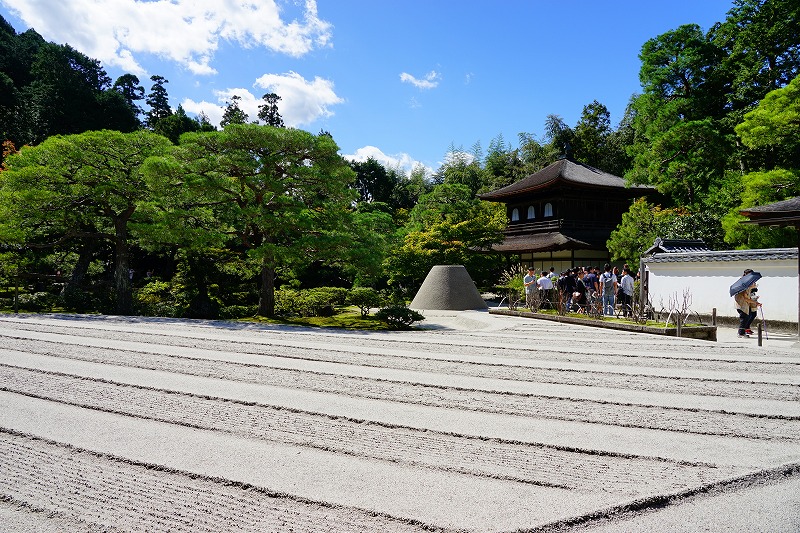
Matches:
[3,341,800,439]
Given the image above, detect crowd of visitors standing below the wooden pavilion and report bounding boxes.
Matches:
[523,263,638,316]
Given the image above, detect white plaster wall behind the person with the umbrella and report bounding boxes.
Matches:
[646,259,798,323]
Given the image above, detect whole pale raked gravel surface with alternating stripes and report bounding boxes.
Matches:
[0,311,800,533]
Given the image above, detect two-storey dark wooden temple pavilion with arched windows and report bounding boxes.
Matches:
[479,159,655,271]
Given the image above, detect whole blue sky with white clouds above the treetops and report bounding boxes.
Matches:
[0,0,732,174]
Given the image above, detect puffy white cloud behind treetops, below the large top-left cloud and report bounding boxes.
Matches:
[181,72,344,127]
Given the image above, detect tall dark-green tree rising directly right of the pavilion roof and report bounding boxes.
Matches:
[626,24,733,207]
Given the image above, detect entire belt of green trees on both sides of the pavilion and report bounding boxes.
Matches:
[0,0,800,317]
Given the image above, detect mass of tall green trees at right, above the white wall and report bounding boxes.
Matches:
[609,0,800,256]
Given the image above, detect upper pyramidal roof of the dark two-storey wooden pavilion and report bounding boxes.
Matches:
[479,159,654,201]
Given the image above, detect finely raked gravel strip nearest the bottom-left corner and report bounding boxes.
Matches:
[0,428,444,532]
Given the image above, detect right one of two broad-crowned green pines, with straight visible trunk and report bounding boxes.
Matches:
[158,124,355,316]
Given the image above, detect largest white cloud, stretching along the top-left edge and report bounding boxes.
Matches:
[0,0,332,74]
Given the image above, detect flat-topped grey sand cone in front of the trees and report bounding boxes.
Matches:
[409,265,488,311]
